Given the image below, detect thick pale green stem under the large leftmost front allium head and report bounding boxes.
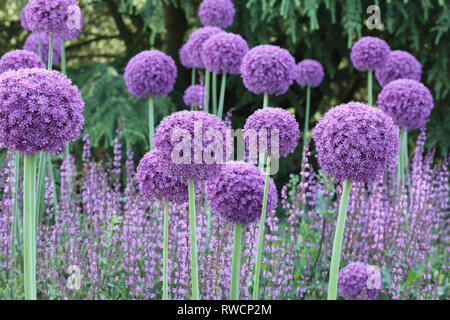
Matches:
[23,154,36,300]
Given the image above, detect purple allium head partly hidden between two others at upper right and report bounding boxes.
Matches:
[375,50,422,87]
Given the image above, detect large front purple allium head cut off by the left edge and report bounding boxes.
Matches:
[0,68,84,154]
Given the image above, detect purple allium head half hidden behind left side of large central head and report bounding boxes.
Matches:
[137,149,188,203]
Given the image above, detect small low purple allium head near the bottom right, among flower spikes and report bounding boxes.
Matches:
[338,262,382,299]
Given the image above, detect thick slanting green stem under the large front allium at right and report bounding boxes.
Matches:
[328,179,352,300]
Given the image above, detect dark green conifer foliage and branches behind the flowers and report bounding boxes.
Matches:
[0,0,450,186]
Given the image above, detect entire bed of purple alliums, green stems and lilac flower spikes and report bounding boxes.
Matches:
[0,0,450,300]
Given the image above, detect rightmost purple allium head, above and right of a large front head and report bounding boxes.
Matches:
[377,79,434,130]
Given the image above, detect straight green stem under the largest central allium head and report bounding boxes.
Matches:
[188,179,200,300]
